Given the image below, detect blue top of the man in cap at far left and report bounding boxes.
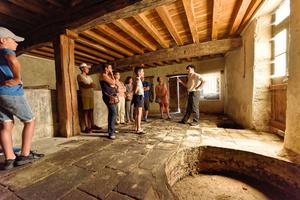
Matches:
[0,48,24,96]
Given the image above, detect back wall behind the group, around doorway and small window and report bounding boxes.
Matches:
[121,58,225,113]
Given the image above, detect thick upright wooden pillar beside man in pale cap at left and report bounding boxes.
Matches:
[53,31,80,137]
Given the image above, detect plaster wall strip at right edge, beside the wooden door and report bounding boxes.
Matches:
[284,0,300,154]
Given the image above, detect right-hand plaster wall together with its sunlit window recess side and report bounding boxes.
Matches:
[225,15,271,131]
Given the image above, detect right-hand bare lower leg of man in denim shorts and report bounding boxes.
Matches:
[21,120,35,156]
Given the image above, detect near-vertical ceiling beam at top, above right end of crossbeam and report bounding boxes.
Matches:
[211,0,222,40]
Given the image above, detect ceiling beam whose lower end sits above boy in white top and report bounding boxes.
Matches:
[96,24,144,54]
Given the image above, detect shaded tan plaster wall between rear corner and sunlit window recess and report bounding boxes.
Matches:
[225,21,256,128]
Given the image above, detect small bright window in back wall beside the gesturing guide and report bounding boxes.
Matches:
[201,72,220,100]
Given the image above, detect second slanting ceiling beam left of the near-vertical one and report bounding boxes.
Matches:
[155,6,183,45]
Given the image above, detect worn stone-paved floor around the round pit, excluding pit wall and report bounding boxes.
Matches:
[0,115,300,200]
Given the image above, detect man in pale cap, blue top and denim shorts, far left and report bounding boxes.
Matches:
[0,27,42,170]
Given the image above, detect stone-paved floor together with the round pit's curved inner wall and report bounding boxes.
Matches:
[0,114,300,200]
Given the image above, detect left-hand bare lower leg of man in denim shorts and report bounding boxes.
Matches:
[0,122,16,159]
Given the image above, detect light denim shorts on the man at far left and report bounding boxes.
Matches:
[0,95,34,122]
